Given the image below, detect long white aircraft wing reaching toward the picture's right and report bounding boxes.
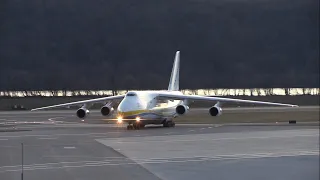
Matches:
[158,94,298,107]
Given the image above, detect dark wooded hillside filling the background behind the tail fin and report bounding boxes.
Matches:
[0,0,319,90]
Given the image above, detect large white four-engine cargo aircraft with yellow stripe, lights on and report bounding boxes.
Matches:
[31,51,297,130]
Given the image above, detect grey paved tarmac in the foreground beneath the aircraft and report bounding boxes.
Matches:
[0,111,319,180]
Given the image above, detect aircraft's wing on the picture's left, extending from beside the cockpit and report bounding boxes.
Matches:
[31,95,125,111]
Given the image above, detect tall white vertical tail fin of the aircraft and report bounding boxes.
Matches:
[168,51,180,91]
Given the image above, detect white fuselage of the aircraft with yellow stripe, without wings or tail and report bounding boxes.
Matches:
[117,91,183,123]
